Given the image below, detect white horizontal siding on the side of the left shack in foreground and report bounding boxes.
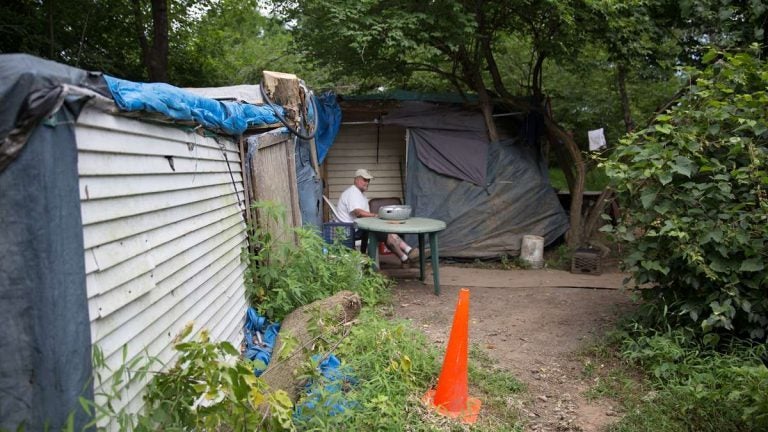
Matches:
[75,108,247,422]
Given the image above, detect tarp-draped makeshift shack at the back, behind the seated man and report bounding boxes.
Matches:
[323,93,568,258]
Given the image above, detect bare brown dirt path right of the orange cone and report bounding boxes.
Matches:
[389,266,631,431]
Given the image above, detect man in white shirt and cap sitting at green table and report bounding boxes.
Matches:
[336,168,414,262]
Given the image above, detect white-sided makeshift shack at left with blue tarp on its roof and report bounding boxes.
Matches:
[0,54,332,430]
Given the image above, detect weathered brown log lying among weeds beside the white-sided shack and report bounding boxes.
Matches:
[261,291,362,403]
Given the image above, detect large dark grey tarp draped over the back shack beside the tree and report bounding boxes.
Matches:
[406,105,568,258]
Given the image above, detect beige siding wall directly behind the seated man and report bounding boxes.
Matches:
[324,124,405,204]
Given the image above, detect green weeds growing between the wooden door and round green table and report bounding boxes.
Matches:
[244,202,387,321]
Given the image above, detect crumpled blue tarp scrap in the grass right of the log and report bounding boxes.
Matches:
[293,354,358,421]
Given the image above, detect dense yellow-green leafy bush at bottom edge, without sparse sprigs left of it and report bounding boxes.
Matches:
[141,326,293,431]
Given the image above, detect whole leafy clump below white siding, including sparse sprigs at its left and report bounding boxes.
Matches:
[80,323,295,432]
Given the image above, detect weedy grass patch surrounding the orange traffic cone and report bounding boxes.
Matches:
[297,308,523,432]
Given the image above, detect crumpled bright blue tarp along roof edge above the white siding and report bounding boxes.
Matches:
[104,75,283,135]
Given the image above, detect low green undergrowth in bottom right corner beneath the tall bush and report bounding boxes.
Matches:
[611,326,768,432]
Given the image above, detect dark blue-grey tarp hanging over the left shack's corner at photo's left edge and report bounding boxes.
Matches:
[0,55,95,431]
